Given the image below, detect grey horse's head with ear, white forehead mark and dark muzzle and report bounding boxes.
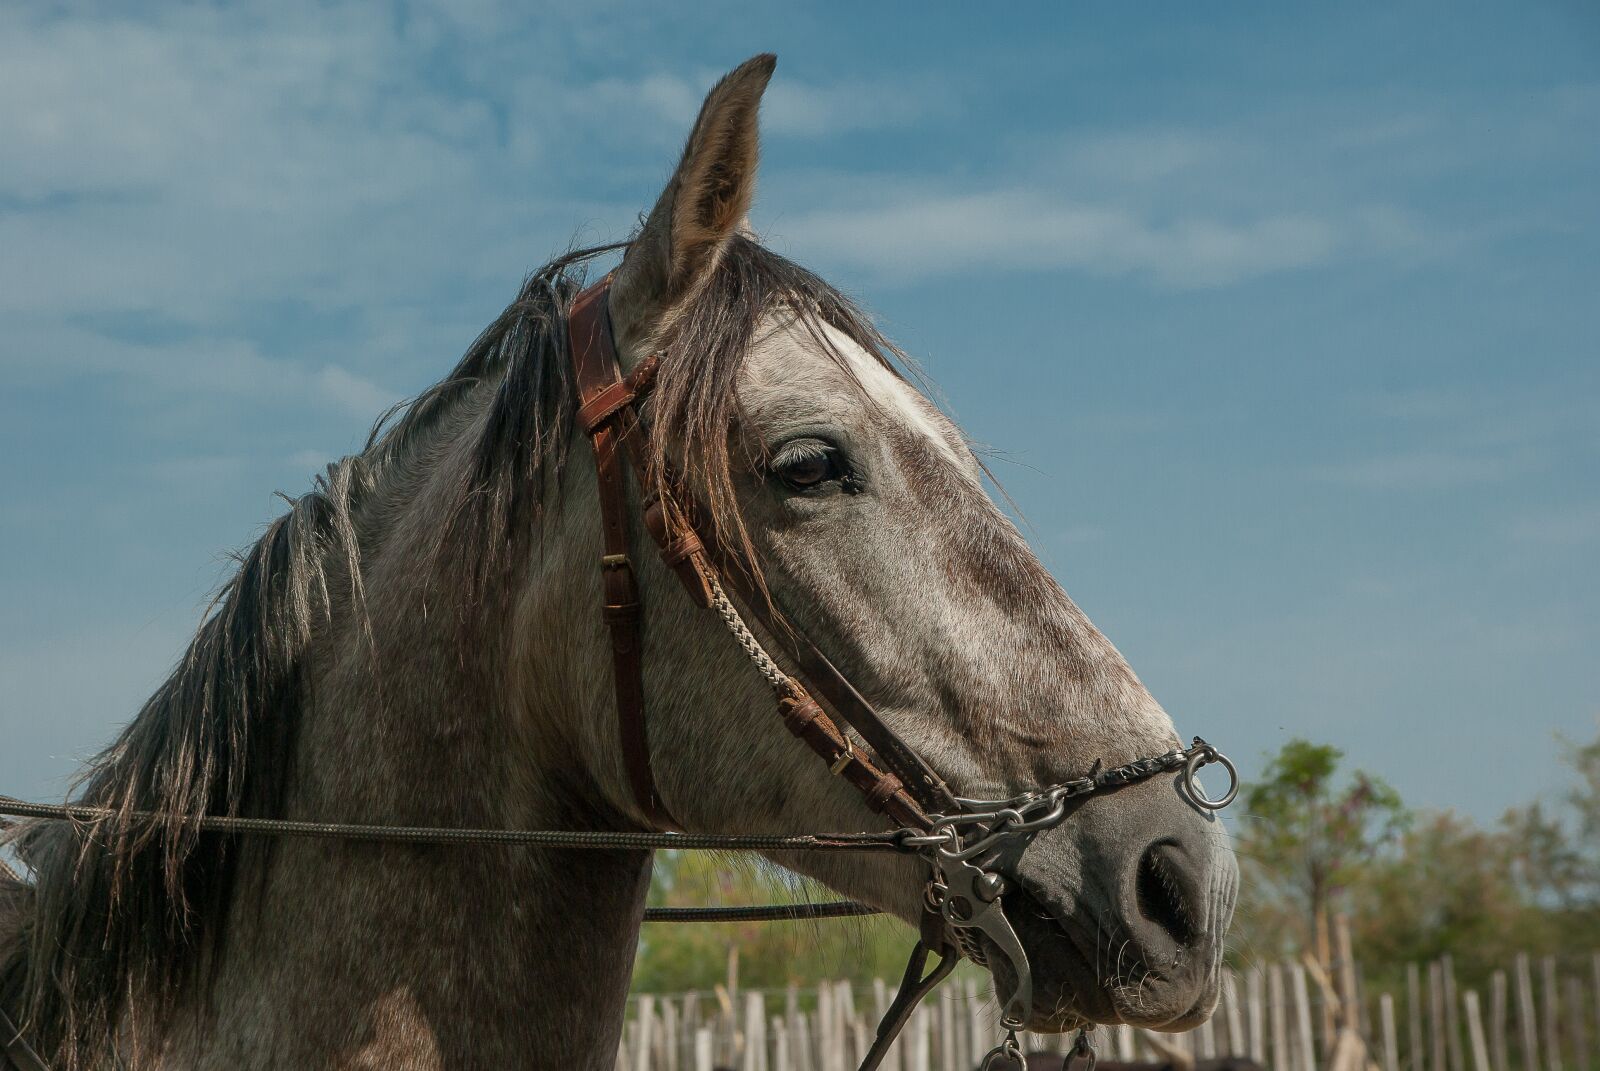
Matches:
[537,56,1237,1029]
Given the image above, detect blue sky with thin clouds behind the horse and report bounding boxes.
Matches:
[0,2,1600,818]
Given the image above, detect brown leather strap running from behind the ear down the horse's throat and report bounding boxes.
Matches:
[566,278,678,829]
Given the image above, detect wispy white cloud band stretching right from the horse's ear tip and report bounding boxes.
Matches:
[778,80,1600,288]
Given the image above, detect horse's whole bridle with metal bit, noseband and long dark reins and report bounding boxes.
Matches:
[0,277,1238,1071]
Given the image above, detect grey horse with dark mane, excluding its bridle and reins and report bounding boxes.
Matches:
[0,56,1237,1071]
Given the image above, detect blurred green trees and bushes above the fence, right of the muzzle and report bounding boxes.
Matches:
[1235,726,1600,985]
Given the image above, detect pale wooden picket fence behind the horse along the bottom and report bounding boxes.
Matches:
[616,927,1600,1071]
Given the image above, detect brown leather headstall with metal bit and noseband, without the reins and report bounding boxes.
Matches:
[568,277,1238,1071]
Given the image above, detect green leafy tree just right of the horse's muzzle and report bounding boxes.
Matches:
[1240,738,1406,961]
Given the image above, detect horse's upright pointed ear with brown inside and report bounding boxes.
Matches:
[611,53,778,362]
